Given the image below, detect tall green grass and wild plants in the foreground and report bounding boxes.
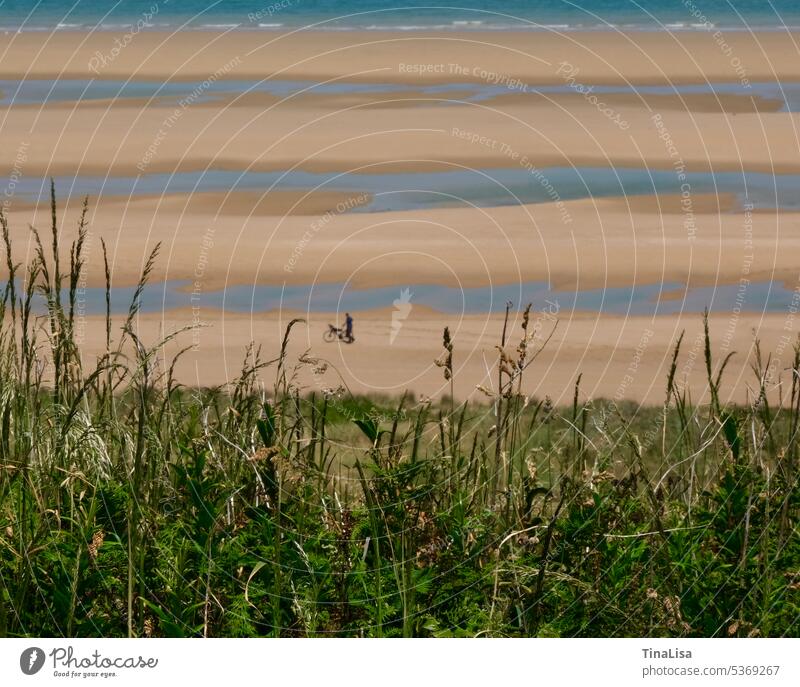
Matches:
[0,189,800,637]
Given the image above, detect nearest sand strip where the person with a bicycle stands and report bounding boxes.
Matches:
[59,307,798,405]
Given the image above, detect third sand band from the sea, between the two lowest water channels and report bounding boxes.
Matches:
[0,194,800,290]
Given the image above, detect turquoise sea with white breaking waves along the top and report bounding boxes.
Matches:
[0,0,800,31]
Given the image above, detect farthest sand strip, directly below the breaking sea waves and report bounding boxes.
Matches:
[0,27,798,84]
